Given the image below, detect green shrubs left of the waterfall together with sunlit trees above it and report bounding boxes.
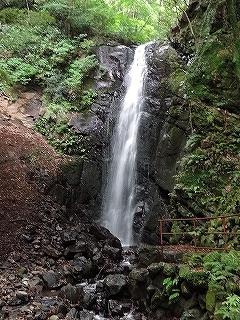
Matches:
[0,0,186,155]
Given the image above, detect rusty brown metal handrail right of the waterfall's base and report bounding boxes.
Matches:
[159,214,240,252]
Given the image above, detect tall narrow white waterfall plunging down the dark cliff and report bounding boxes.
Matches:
[102,45,147,245]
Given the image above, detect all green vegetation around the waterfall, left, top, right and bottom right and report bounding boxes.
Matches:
[0,0,240,319]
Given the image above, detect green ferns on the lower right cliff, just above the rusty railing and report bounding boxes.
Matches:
[175,104,240,220]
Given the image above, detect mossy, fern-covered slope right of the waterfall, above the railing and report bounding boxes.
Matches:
[169,0,240,225]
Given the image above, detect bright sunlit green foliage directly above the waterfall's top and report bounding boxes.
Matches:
[106,0,186,42]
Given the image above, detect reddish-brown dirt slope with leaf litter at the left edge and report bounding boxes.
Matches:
[0,89,61,261]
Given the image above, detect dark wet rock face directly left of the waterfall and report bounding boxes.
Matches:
[64,45,134,222]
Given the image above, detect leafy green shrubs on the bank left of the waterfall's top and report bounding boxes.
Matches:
[0,8,98,156]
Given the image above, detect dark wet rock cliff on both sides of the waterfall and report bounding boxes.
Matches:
[66,42,189,244]
